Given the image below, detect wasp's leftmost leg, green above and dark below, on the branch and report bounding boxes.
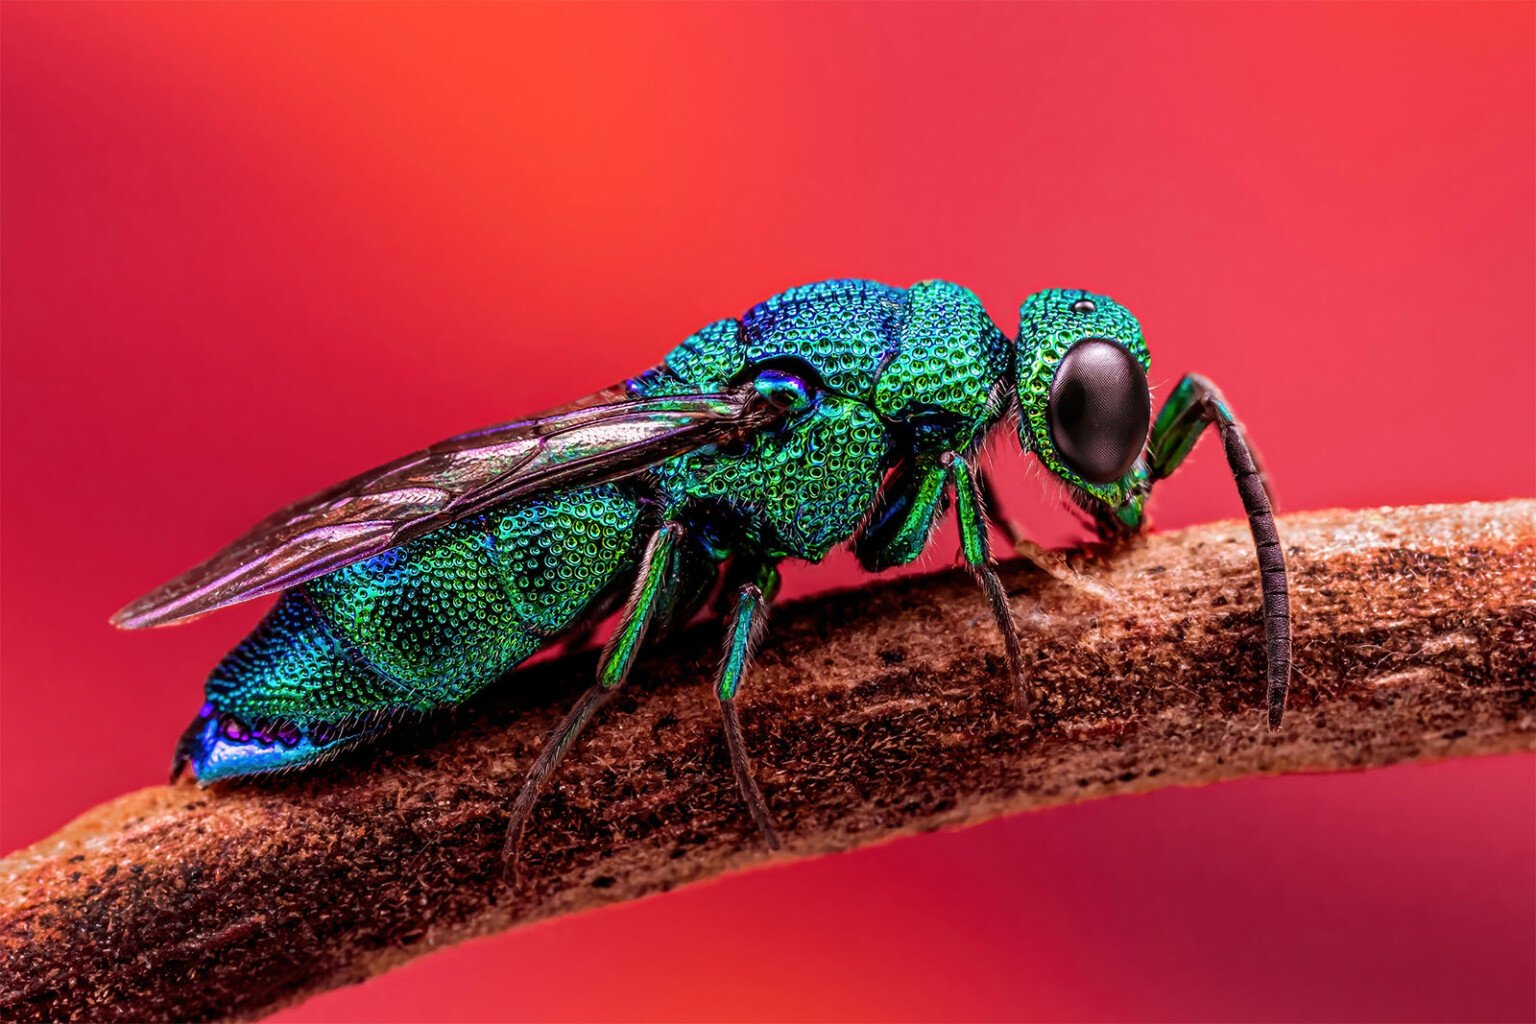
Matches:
[502,524,682,877]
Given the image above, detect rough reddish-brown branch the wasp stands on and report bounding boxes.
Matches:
[0,502,1536,1019]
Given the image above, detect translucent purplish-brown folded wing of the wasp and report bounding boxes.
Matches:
[112,385,779,629]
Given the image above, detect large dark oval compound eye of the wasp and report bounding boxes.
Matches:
[1049,338,1152,484]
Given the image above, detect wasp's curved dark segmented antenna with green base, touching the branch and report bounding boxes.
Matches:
[1148,373,1290,729]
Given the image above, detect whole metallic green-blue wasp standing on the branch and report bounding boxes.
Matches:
[114,281,1290,852]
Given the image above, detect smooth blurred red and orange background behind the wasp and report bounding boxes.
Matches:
[0,3,1536,1021]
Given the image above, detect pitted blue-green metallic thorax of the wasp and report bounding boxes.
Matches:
[630,279,1012,562]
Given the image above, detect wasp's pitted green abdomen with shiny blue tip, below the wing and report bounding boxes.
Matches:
[180,485,641,781]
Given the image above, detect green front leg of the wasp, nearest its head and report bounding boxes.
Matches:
[854,451,1029,714]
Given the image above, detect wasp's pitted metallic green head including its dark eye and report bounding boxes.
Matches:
[1015,289,1152,527]
